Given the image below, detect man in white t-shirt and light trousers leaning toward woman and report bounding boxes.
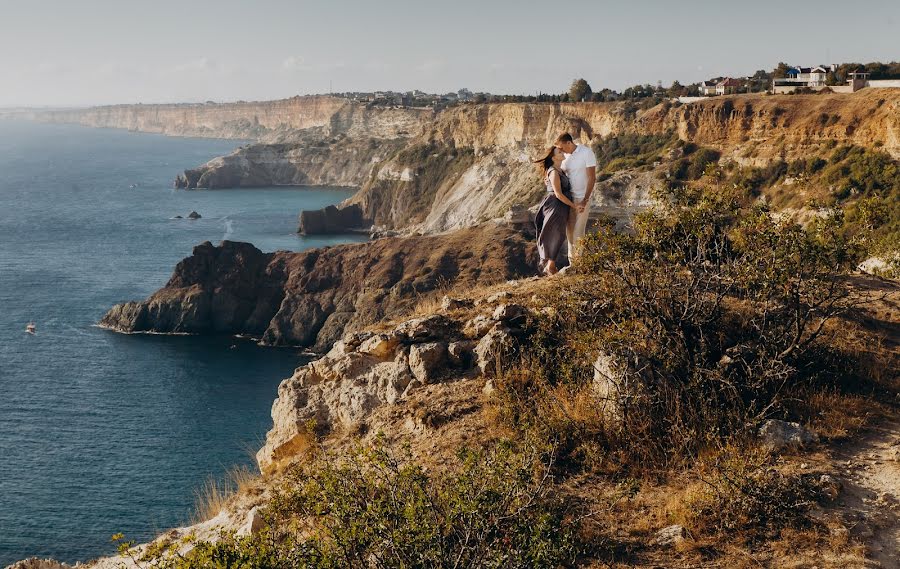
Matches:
[555,132,597,264]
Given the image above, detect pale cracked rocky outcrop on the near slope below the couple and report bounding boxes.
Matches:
[257,298,527,473]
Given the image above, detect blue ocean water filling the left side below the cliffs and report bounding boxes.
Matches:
[0,120,370,567]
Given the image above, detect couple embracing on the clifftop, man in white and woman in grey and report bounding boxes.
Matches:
[534,132,597,275]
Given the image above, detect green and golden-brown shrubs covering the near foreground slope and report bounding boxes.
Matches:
[119,184,891,569]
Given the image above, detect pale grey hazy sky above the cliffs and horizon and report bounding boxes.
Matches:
[0,0,900,107]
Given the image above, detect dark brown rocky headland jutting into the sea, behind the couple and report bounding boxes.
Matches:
[100,224,536,351]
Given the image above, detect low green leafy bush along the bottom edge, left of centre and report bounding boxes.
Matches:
[134,444,581,569]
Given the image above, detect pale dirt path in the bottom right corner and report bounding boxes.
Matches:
[834,419,900,569]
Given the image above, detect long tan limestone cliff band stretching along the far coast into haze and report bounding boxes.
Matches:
[35,89,900,232]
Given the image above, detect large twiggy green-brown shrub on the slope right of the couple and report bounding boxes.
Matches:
[500,189,859,469]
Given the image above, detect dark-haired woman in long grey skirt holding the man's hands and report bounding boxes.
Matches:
[534,146,577,275]
